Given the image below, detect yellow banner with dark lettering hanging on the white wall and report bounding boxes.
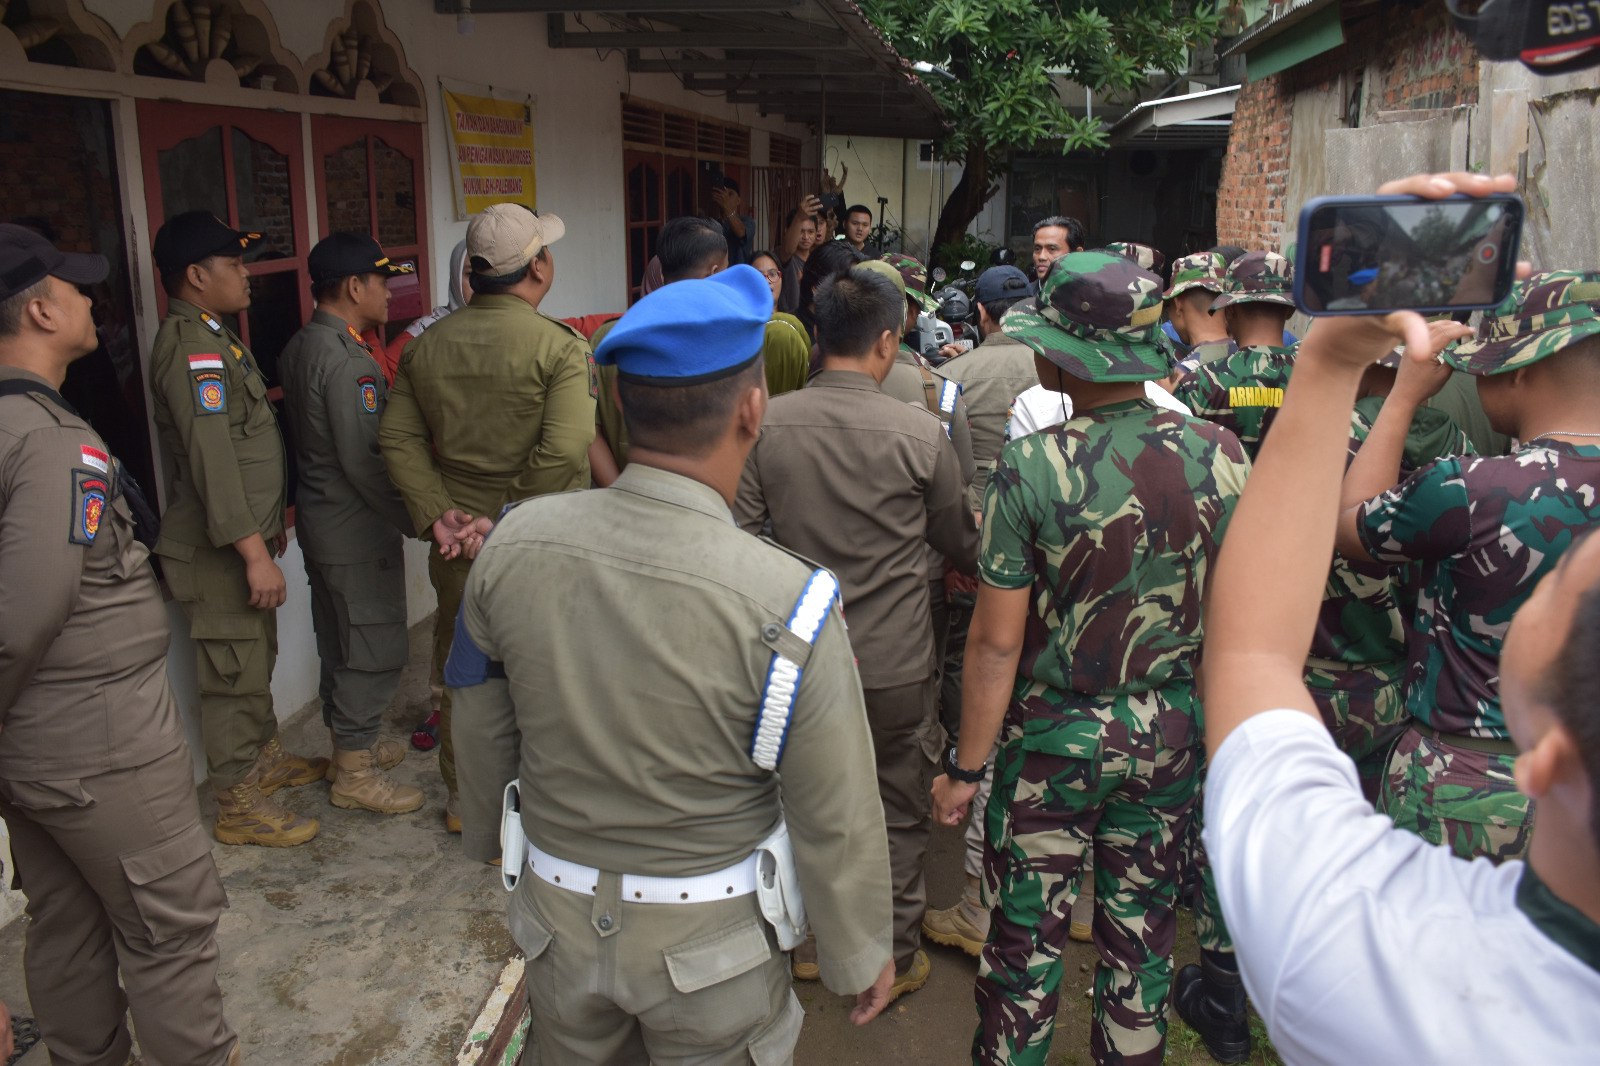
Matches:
[440,88,539,218]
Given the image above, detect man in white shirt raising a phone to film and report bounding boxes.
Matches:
[1203,174,1600,1064]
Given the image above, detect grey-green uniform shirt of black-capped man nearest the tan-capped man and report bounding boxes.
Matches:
[278,311,411,565]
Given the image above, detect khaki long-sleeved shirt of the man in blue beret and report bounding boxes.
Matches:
[451,464,896,989]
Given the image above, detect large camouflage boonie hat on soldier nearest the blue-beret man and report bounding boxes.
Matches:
[1000,251,1173,381]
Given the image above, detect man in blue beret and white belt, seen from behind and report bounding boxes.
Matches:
[445,266,896,1066]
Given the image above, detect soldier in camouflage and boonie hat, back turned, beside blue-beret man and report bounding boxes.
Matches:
[934,251,1250,1066]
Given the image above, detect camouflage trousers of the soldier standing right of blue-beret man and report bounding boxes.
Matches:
[973,685,1202,1066]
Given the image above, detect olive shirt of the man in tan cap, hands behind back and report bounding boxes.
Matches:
[378,295,595,536]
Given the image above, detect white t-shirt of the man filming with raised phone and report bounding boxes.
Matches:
[1205,711,1600,1066]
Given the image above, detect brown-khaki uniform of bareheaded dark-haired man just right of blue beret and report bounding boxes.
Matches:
[734,370,978,973]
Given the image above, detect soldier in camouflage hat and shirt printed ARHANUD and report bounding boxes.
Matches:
[1173,251,1294,459]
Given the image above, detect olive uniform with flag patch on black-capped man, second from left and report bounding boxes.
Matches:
[150,299,285,789]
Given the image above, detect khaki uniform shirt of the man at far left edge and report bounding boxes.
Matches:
[0,367,184,783]
